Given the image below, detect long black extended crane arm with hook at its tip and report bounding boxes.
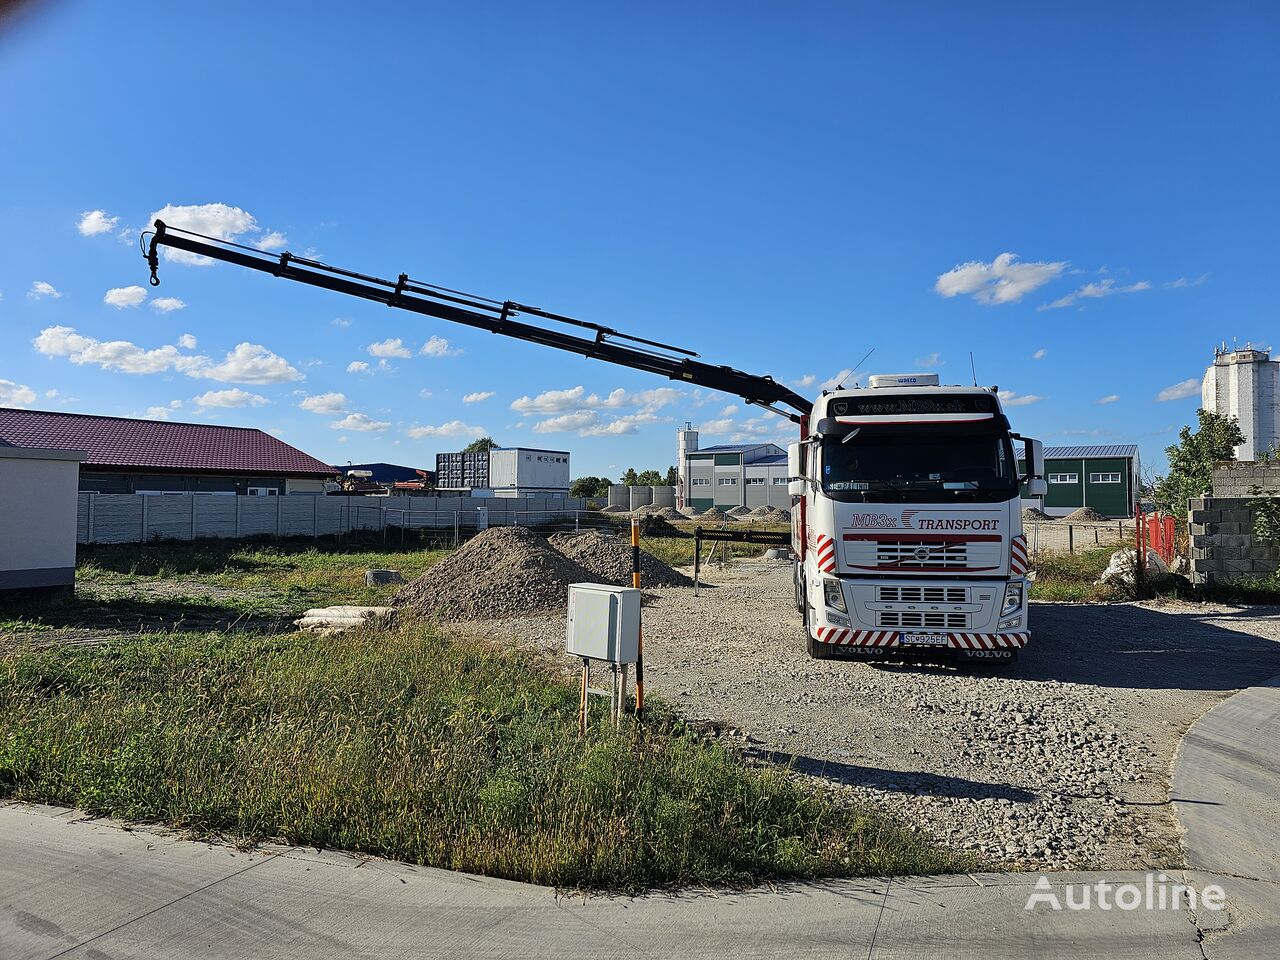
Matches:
[142,220,813,422]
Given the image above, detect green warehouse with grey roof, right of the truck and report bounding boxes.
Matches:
[1018,443,1139,517]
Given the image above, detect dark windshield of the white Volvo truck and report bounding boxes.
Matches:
[822,425,1019,503]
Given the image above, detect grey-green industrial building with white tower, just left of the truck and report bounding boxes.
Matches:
[676,424,791,509]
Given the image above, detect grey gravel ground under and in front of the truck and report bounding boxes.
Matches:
[462,561,1280,869]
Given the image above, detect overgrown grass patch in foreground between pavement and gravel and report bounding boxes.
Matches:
[0,623,973,891]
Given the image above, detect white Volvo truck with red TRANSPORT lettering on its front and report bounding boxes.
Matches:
[787,374,1044,664]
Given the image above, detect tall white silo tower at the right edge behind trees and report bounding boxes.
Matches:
[1201,346,1280,461]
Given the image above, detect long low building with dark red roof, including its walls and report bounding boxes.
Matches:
[0,407,337,497]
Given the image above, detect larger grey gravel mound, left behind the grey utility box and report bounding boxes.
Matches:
[394,526,593,620]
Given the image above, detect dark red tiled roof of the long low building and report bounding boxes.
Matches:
[0,407,335,476]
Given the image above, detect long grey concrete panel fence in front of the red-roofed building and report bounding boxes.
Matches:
[76,493,586,543]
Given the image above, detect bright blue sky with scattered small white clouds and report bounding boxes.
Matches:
[0,0,1280,479]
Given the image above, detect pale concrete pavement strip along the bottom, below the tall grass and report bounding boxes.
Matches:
[0,805,1230,960]
